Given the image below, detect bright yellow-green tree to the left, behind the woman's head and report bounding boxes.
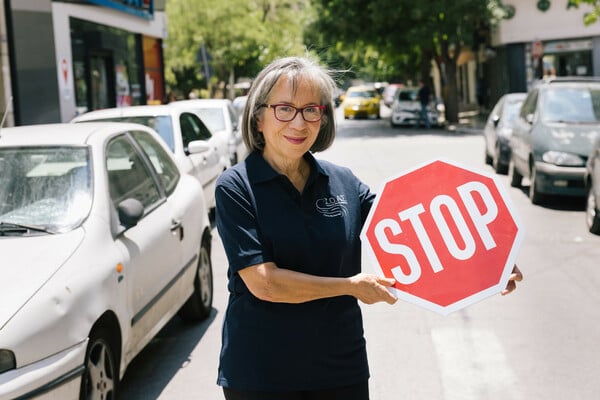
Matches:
[165,0,310,97]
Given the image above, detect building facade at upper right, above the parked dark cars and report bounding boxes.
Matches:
[480,0,600,103]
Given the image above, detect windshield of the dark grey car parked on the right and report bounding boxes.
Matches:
[541,86,600,123]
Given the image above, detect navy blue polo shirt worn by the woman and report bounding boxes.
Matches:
[216,152,375,391]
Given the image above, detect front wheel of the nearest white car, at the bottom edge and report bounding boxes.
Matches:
[79,328,119,400]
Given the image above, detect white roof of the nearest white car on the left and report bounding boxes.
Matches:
[0,122,149,147]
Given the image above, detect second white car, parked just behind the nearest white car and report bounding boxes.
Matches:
[72,103,228,210]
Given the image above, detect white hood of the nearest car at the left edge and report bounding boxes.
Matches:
[0,229,83,329]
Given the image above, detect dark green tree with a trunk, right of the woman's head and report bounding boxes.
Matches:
[313,0,502,122]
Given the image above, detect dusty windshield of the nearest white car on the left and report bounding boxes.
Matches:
[0,146,92,236]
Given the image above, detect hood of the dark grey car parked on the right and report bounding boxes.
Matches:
[539,123,600,157]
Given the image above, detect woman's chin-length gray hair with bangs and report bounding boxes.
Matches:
[242,57,336,152]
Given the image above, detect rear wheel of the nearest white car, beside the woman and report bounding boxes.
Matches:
[179,241,213,322]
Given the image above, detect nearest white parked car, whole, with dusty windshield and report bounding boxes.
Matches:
[0,123,213,399]
